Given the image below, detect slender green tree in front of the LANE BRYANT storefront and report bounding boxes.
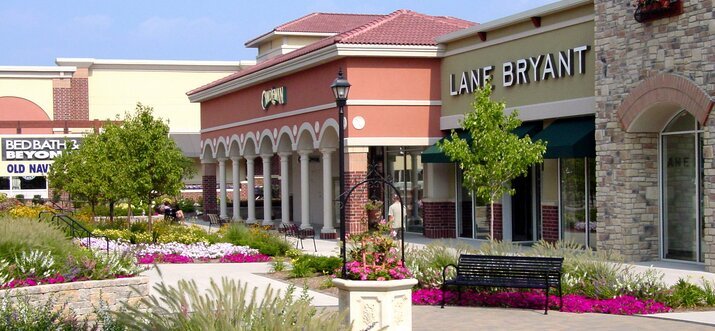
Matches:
[438,85,546,238]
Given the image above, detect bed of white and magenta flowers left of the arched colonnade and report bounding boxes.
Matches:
[82,238,270,264]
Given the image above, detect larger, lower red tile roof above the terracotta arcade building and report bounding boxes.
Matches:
[187,9,475,95]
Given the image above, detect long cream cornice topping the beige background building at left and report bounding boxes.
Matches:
[55,58,256,71]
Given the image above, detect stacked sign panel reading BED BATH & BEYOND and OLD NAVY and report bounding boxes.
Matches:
[0,135,83,176]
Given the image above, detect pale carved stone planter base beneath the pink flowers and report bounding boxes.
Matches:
[333,278,417,331]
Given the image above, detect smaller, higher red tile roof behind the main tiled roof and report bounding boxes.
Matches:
[246,13,385,45]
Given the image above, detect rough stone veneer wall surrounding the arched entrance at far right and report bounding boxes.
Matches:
[594,0,715,271]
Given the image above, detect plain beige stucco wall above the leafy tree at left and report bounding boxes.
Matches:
[89,69,232,132]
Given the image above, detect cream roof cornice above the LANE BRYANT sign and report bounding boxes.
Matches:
[436,0,593,43]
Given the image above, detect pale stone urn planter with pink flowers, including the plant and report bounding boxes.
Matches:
[333,219,417,330]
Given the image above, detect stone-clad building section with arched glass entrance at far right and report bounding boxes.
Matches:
[594,0,715,272]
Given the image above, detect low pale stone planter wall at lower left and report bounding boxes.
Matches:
[0,277,149,320]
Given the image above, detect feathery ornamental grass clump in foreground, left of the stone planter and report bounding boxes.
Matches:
[116,278,349,331]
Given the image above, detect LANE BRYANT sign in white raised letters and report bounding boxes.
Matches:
[449,45,591,96]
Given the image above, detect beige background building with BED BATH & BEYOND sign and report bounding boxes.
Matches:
[0,58,255,198]
